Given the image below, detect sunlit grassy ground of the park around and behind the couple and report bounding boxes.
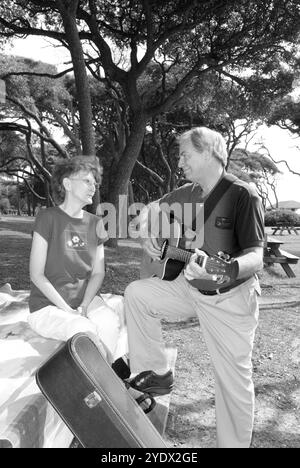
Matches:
[0,217,300,448]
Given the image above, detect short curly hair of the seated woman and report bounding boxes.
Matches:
[51,156,101,204]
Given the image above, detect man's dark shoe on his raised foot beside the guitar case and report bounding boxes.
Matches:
[127,370,174,395]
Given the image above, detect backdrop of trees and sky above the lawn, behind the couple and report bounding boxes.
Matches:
[0,0,300,225]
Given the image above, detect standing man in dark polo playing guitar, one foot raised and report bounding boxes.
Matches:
[125,127,264,448]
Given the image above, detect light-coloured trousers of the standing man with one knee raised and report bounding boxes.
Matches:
[125,275,260,448]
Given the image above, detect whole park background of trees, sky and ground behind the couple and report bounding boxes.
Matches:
[0,0,300,447]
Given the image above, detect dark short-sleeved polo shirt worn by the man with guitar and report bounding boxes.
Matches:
[160,174,264,289]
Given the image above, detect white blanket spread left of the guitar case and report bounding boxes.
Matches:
[0,284,73,448]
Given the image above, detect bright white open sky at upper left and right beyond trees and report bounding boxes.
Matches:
[5,37,300,203]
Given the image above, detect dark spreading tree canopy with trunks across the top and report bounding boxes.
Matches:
[0,0,300,226]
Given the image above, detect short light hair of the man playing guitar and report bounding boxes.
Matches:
[179,127,228,167]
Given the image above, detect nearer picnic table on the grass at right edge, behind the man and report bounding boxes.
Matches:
[264,236,299,278]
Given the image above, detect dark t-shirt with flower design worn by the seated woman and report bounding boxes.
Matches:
[29,207,108,312]
